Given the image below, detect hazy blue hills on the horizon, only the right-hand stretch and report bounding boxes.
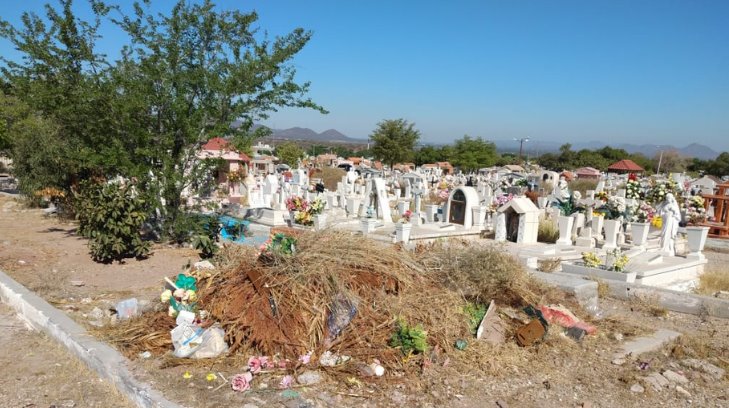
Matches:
[494,140,719,160]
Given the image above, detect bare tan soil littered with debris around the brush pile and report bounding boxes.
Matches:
[0,197,729,407]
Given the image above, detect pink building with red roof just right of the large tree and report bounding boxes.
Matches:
[197,137,251,197]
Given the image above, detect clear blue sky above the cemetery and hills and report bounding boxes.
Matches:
[0,0,729,151]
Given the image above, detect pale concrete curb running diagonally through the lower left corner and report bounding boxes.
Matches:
[0,271,182,408]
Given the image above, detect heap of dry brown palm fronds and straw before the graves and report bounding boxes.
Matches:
[99,231,577,369]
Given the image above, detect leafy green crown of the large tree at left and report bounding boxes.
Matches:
[0,0,326,236]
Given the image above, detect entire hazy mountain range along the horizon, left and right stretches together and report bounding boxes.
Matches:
[253,127,719,160]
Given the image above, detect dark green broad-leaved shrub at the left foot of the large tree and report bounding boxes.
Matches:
[75,182,150,262]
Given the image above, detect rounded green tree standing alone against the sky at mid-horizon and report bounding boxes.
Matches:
[370,119,420,169]
